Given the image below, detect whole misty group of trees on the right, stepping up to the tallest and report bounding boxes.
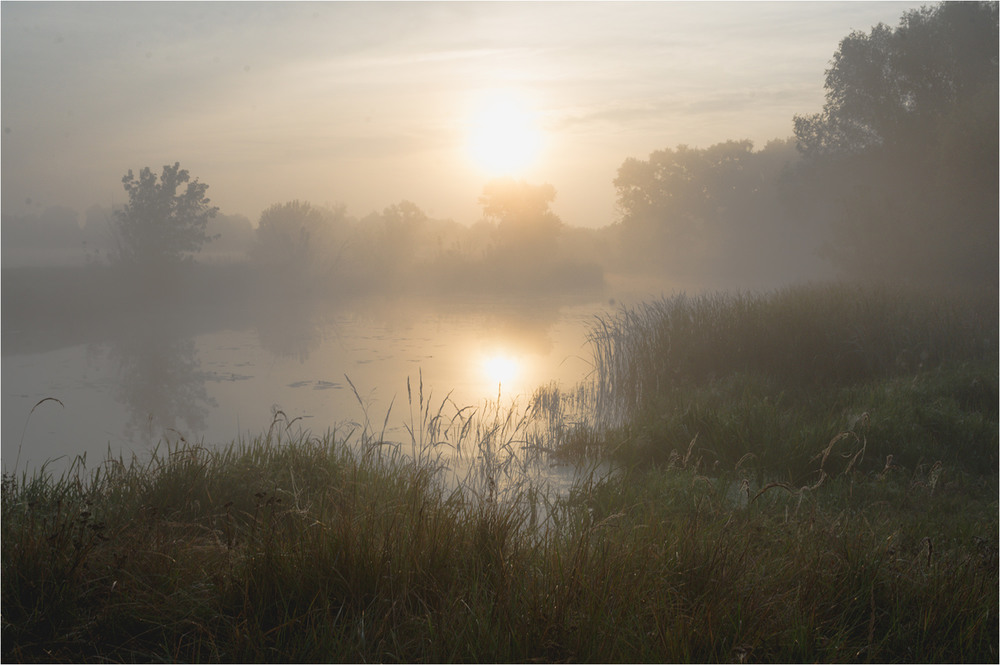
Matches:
[615,2,998,284]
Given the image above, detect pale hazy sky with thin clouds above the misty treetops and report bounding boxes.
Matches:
[0,2,923,227]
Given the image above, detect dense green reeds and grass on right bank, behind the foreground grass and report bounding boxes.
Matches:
[590,285,998,477]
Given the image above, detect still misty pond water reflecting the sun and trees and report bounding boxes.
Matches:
[2,296,615,472]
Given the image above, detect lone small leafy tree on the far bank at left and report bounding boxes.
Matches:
[113,162,219,271]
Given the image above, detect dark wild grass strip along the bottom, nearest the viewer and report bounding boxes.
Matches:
[2,426,998,662]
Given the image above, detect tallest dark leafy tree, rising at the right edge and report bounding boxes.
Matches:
[795,2,998,283]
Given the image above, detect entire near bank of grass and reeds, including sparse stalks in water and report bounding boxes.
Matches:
[0,285,1000,662]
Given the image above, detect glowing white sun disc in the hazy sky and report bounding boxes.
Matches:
[468,92,542,176]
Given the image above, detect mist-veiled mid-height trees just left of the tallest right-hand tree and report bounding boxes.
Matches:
[614,140,815,280]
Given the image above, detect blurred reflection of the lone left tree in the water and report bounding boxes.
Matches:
[110,315,216,445]
